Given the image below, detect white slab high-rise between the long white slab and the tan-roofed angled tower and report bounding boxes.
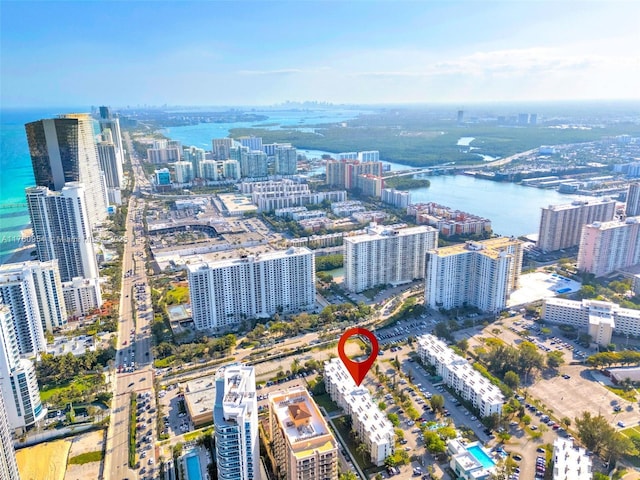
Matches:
[344,225,438,292]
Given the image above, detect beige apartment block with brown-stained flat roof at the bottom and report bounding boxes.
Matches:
[269,387,338,480]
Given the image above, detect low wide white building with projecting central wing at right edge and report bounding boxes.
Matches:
[542,298,640,345]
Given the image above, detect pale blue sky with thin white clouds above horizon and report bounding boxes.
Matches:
[0,0,640,108]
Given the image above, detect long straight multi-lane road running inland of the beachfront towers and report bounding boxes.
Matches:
[104,140,158,480]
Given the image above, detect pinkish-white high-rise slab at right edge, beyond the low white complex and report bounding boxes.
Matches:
[578,217,640,277]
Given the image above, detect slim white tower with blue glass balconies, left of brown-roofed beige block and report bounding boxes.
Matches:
[213,365,261,480]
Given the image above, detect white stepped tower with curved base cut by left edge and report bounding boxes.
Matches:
[0,303,47,432]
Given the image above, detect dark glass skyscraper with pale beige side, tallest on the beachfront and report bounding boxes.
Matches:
[25,113,108,227]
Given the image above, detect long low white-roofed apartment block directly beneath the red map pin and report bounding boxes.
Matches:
[324,358,396,466]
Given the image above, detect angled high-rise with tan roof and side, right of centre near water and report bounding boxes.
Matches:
[424,237,522,312]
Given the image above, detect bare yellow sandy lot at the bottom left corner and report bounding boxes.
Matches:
[16,440,70,480]
